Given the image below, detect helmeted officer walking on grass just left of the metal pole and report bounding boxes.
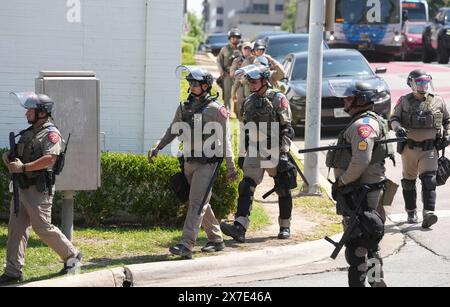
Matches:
[221,65,297,243]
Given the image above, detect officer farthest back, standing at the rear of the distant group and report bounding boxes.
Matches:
[217,29,242,111]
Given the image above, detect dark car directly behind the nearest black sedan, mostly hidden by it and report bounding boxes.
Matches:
[265,34,328,63]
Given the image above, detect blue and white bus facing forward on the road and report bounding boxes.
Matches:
[328,0,402,58]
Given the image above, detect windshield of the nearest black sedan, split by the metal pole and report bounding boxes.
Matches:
[291,55,373,80]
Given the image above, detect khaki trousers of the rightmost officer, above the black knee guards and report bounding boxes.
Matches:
[402,146,439,180]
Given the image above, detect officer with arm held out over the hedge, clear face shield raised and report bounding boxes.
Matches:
[148,66,237,259]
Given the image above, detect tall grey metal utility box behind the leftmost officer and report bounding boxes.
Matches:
[36,71,100,191]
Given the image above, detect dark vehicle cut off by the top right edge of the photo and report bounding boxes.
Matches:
[422,8,450,64]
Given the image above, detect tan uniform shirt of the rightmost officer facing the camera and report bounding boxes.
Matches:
[391,95,450,142]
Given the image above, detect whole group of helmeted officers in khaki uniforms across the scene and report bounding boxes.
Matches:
[0,25,450,287]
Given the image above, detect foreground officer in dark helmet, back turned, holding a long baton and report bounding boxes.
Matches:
[326,82,394,287]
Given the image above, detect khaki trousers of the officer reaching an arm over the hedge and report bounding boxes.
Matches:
[181,162,223,250]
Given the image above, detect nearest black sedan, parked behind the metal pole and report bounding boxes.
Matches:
[284,49,391,136]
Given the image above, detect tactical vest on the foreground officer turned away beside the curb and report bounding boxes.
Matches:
[326,111,394,170]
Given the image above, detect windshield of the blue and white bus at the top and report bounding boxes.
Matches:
[336,0,401,24]
